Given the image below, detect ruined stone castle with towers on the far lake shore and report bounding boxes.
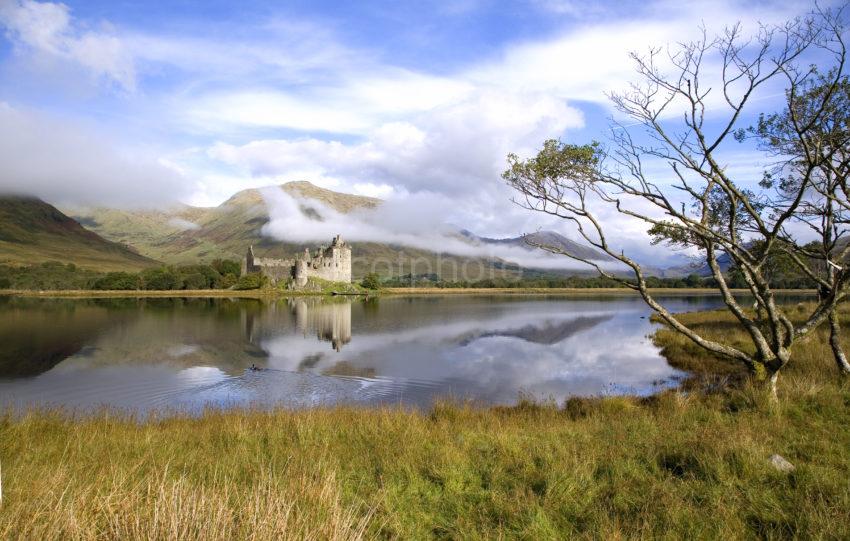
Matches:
[242,235,351,287]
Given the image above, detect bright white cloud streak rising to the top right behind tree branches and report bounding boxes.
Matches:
[468,0,808,106]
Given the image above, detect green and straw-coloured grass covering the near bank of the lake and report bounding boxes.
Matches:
[0,302,850,539]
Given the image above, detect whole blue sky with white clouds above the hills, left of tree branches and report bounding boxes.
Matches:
[0,0,828,262]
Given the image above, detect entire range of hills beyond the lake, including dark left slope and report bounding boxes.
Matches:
[0,181,689,279]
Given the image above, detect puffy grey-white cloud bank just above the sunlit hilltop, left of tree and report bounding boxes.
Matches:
[204,90,583,193]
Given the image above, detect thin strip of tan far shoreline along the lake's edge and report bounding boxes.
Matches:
[0,287,816,299]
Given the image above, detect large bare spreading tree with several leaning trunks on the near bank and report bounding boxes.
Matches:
[503,6,850,394]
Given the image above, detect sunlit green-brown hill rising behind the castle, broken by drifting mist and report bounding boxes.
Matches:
[68,182,521,278]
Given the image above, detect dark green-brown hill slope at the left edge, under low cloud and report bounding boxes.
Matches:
[0,196,157,271]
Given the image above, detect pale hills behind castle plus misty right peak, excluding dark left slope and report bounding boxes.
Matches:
[54,181,644,279]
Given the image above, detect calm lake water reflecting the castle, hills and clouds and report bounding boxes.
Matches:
[0,296,808,413]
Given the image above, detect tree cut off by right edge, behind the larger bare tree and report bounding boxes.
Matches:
[737,44,850,374]
